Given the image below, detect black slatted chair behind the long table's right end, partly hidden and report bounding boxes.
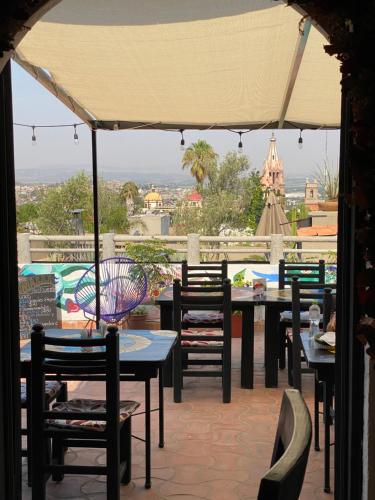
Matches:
[279,259,325,370]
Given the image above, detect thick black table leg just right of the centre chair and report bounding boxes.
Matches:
[241,307,254,389]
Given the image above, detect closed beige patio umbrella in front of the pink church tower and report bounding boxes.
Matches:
[255,191,292,236]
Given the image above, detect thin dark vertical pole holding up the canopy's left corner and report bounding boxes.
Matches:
[91,128,100,329]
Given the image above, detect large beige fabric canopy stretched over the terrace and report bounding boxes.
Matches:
[15,0,340,129]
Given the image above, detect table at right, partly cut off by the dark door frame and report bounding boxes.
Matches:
[301,331,335,493]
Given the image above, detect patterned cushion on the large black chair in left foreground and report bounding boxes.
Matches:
[47,399,139,431]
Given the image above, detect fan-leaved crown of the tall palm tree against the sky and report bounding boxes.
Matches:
[182,139,219,186]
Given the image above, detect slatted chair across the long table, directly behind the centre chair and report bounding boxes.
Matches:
[181,260,228,328]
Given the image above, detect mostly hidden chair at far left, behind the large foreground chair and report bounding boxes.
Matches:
[20,380,68,486]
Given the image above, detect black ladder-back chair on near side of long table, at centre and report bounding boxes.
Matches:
[173,279,231,403]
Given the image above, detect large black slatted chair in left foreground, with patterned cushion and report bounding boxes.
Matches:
[31,325,139,500]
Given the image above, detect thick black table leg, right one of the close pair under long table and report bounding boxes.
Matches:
[264,304,280,387]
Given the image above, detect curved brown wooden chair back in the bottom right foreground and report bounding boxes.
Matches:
[258,389,311,500]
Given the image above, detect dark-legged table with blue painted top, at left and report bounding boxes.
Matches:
[21,329,176,488]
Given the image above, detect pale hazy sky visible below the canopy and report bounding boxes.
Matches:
[12,63,339,182]
